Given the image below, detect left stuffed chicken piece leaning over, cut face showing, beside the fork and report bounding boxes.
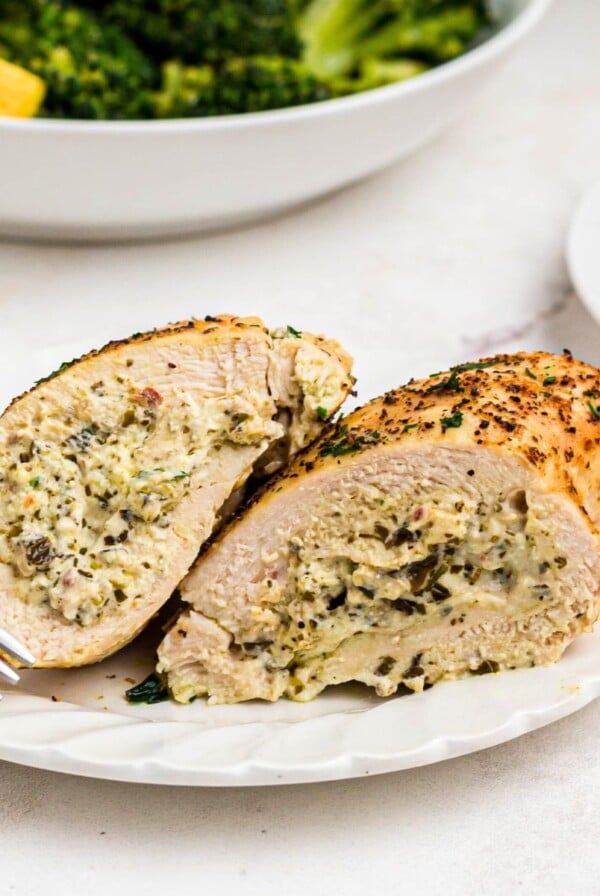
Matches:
[0,316,353,666]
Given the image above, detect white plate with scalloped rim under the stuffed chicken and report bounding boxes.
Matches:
[0,616,600,786]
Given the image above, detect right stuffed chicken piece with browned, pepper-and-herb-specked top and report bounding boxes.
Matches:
[158,354,600,703]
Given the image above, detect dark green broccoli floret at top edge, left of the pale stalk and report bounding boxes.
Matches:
[87,0,301,65]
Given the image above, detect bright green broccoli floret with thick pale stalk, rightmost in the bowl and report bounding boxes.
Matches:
[299,0,485,80]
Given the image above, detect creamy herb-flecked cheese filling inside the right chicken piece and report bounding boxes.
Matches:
[229,487,568,700]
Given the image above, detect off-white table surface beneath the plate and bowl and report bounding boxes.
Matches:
[0,0,600,896]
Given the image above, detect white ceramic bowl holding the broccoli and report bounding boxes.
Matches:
[0,0,550,240]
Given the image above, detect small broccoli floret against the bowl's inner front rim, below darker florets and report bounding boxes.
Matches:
[153,56,333,118]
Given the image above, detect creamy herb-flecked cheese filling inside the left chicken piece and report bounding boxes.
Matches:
[0,377,283,625]
